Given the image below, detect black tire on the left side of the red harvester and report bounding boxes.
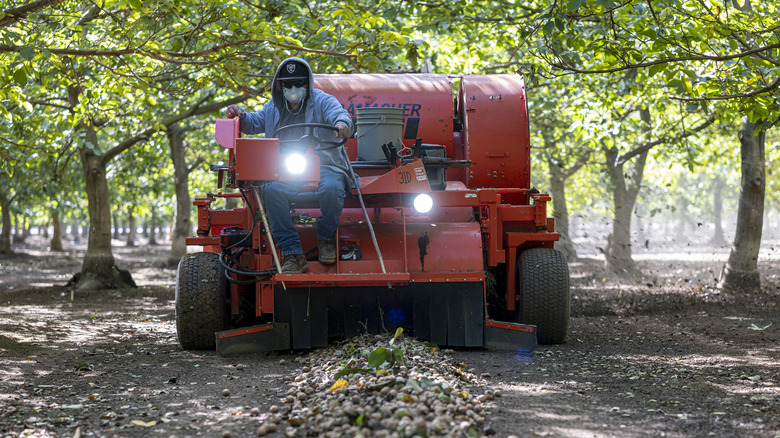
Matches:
[176,252,227,350]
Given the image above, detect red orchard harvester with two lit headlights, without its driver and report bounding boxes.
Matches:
[176,74,569,355]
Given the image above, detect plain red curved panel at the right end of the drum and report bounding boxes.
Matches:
[458,75,531,188]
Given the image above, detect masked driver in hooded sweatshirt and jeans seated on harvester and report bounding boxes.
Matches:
[225,57,353,274]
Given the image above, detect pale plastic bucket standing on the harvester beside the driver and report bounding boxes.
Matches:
[357,107,404,161]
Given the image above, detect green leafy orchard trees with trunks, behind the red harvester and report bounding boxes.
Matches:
[0,0,780,294]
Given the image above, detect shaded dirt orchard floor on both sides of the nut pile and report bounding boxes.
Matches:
[0,236,780,438]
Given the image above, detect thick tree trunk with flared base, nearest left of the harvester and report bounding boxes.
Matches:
[68,86,135,290]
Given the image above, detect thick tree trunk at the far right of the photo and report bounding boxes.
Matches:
[718,118,766,292]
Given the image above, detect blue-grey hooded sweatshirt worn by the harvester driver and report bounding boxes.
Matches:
[239,57,354,189]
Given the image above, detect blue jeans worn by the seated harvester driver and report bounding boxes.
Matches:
[263,168,347,256]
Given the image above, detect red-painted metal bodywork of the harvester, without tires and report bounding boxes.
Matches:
[187,75,559,322]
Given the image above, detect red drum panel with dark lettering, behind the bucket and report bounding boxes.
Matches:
[314,74,453,159]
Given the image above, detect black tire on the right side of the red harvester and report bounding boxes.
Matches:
[515,248,571,344]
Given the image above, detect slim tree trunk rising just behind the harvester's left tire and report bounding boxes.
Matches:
[167,124,192,265]
